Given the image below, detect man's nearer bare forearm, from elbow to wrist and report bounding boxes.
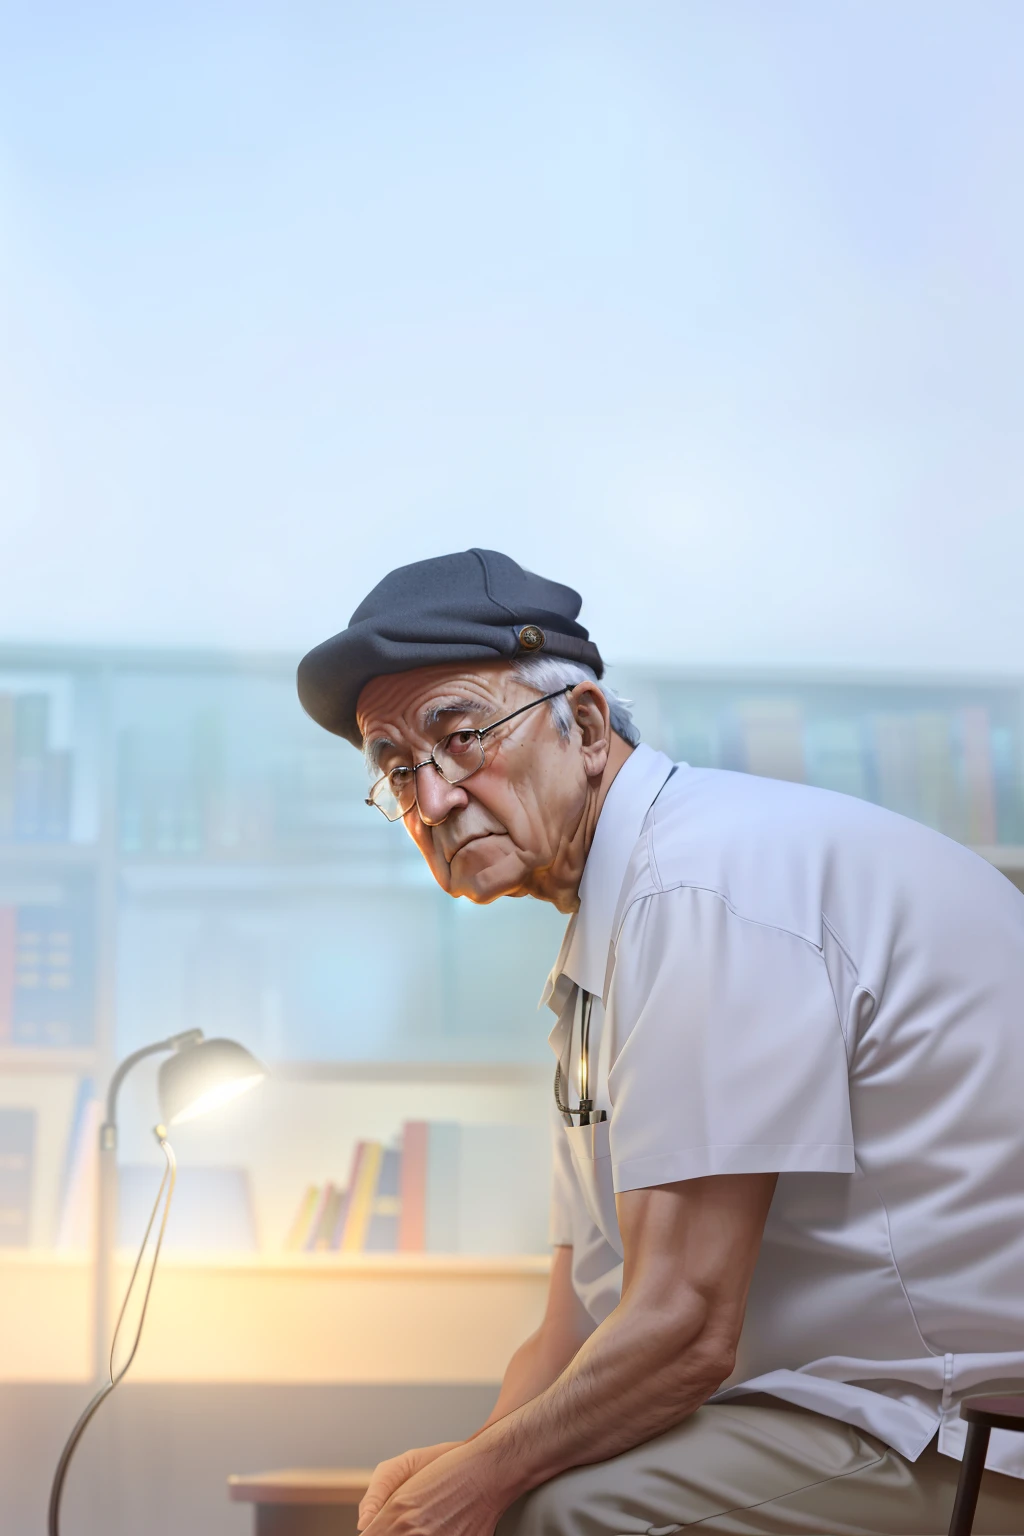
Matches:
[463,1298,731,1504]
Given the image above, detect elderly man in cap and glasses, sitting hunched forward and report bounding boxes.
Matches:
[299,550,1024,1536]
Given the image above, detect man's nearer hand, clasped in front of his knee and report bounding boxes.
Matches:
[359,1441,508,1536]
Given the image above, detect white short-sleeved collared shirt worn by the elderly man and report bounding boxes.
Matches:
[543,746,1024,1478]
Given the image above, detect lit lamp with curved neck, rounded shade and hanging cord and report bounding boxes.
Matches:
[48,1029,266,1536]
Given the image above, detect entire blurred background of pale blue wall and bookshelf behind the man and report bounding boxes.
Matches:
[0,0,1024,1536]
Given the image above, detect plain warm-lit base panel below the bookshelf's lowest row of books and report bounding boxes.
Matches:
[0,1250,550,1384]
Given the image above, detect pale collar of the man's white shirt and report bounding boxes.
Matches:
[540,743,674,1012]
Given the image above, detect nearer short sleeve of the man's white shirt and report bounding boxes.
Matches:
[606,886,855,1190]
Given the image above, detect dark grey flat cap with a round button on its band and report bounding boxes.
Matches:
[298,550,605,746]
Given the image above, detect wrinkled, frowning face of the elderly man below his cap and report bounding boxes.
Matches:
[356,662,588,902]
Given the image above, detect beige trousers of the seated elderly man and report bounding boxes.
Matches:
[496,1398,1024,1536]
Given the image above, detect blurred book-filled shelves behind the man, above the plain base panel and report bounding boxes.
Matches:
[0,645,1024,1349]
